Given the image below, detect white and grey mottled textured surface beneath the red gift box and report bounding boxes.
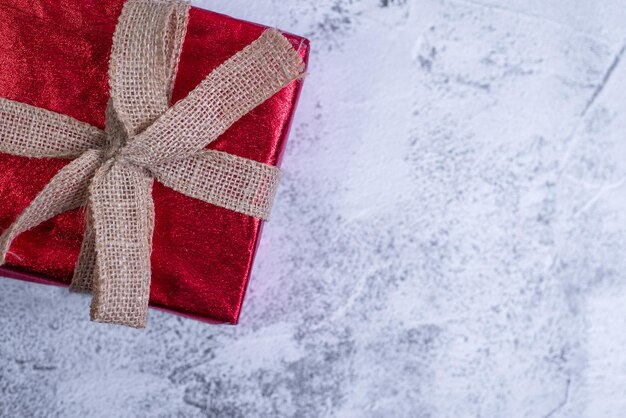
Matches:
[0,0,626,418]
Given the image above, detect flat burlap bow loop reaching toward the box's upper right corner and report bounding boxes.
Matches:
[124,29,304,167]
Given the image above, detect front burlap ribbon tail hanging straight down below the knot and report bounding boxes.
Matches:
[87,162,154,328]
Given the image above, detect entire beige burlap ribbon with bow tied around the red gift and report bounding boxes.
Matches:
[0,0,304,328]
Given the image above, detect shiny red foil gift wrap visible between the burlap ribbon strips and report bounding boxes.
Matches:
[0,0,309,323]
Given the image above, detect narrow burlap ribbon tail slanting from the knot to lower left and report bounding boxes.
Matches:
[0,150,100,265]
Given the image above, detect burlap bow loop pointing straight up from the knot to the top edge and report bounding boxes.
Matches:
[109,0,189,138]
